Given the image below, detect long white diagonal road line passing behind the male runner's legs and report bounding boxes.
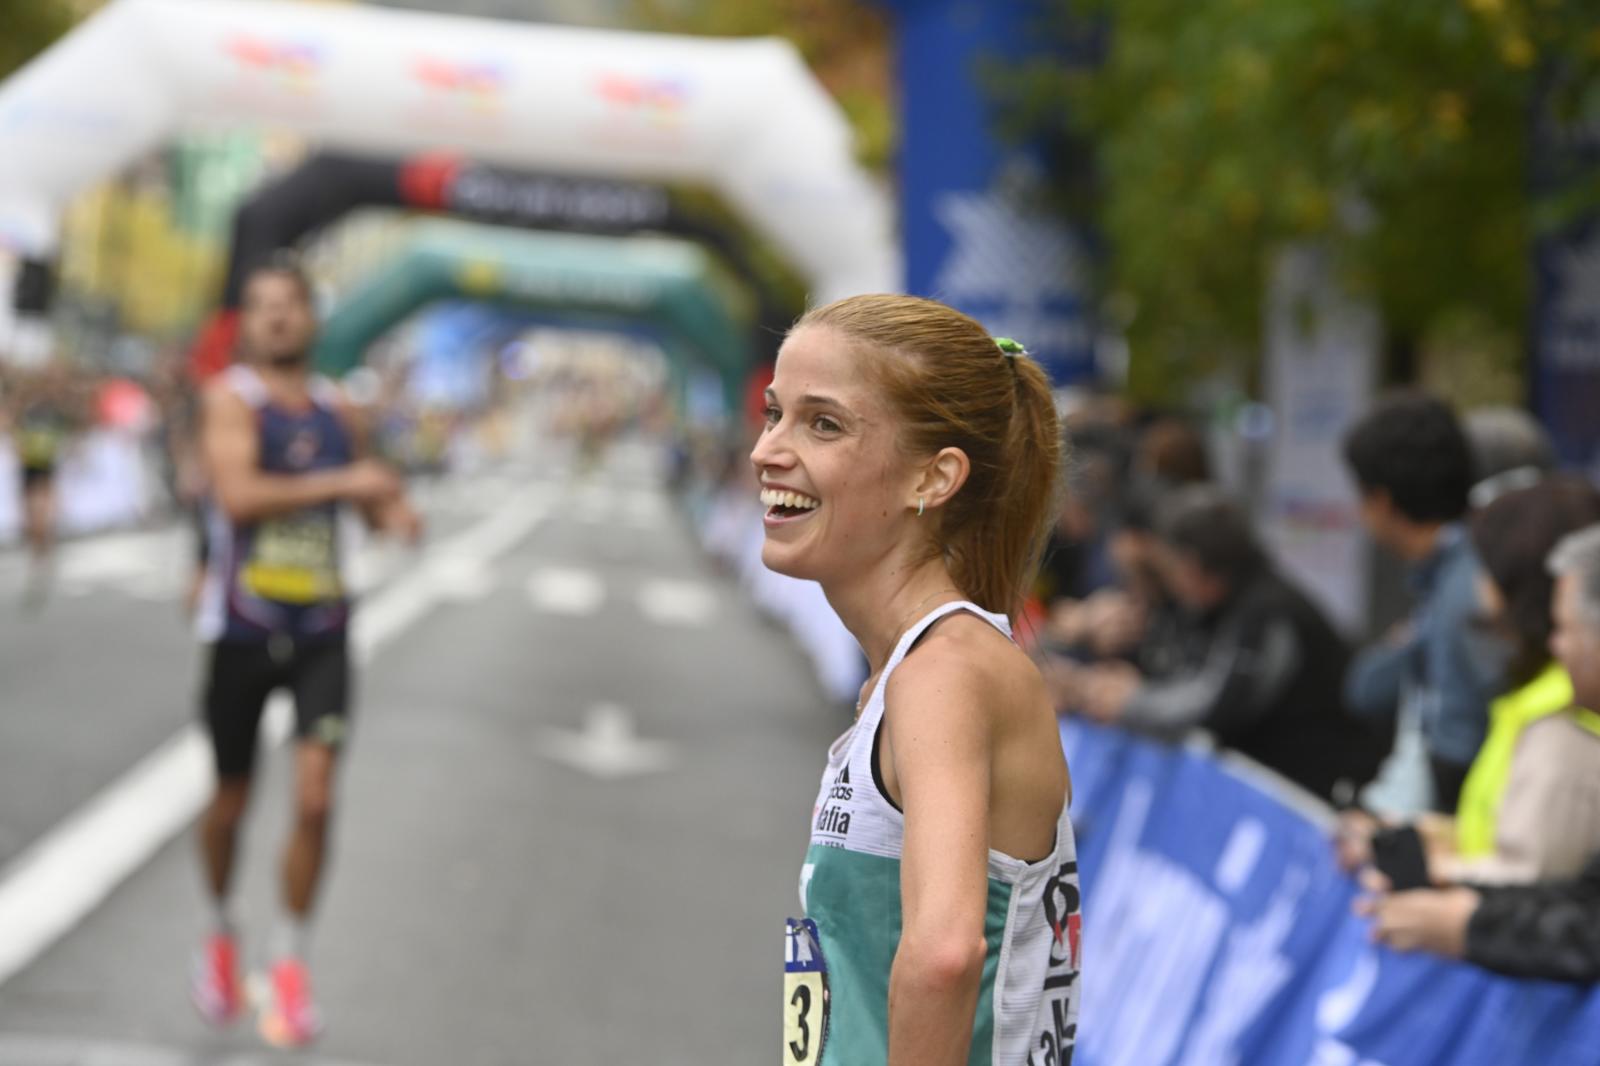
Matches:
[0,491,550,984]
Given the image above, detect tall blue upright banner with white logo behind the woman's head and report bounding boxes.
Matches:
[883,0,1094,384]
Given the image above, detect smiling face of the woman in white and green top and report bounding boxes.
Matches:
[750,325,917,583]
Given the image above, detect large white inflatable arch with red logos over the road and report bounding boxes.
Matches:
[0,0,901,299]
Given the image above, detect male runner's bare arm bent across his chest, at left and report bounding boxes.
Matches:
[200,383,397,522]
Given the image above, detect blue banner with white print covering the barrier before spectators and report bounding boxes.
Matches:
[1062,720,1600,1066]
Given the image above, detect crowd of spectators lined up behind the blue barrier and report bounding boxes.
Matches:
[1034,385,1600,981]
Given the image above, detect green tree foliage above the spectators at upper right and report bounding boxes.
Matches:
[1010,0,1600,398]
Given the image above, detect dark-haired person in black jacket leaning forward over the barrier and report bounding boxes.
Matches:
[1077,485,1392,799]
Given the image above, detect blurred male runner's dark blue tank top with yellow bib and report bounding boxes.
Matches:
[198,367,354,642]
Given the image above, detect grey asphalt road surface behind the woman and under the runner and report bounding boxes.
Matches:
[0,432,845,1066]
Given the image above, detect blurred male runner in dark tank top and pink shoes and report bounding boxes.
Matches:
[192,261,421,1047]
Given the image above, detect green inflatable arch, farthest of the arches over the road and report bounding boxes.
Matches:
[317,221,754,410]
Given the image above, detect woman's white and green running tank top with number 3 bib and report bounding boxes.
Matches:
[784,602,1080,1066]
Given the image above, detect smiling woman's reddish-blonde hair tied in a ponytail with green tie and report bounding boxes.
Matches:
[790,295,1062,615]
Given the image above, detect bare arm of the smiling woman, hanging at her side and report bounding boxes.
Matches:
[882,648,994,1066]
